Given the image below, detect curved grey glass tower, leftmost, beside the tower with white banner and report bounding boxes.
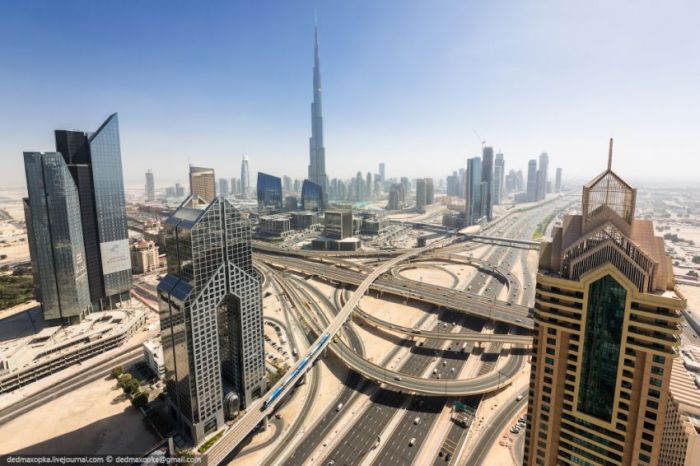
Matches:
[24,152,92,325]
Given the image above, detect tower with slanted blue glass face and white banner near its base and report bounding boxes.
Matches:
[55,113,131,310]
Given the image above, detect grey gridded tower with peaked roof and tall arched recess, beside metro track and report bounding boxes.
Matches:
[158,196,265,444]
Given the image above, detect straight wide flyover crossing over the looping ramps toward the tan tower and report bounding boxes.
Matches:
[256,255,534,330]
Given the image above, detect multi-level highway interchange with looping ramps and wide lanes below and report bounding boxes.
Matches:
[217,200,576,465]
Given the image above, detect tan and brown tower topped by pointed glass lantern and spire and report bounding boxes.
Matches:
[524,141,686,466]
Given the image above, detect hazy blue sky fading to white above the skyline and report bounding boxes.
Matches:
[0,0,700,187]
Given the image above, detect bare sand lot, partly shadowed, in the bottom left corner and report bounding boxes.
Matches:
[0,366,158,454]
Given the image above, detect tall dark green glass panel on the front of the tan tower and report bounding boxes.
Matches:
[578,275,627,422]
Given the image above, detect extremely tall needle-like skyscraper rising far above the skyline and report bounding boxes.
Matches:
[309,27,328,209]
